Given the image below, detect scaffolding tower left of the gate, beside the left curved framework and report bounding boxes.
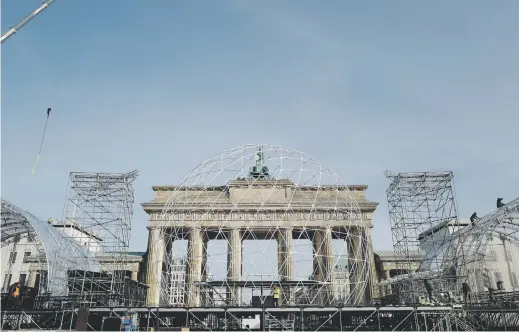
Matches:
[54,171,138,304]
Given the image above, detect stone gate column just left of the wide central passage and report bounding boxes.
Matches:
[227,228,243,305]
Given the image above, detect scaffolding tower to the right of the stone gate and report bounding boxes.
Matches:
[386,172,459,303]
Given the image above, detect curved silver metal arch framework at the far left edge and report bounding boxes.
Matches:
[1,199,91,296]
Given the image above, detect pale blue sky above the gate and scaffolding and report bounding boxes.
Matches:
[1,0,519,250]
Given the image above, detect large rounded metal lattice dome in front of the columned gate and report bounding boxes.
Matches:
[148,145,373,307]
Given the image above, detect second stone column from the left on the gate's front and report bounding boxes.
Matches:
[186,228,204,307]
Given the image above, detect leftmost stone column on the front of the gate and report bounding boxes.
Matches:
[146,227,164,307]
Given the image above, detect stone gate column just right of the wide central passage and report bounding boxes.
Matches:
[276,228,294,304]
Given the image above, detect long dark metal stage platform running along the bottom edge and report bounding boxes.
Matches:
[2,305,519,331]
